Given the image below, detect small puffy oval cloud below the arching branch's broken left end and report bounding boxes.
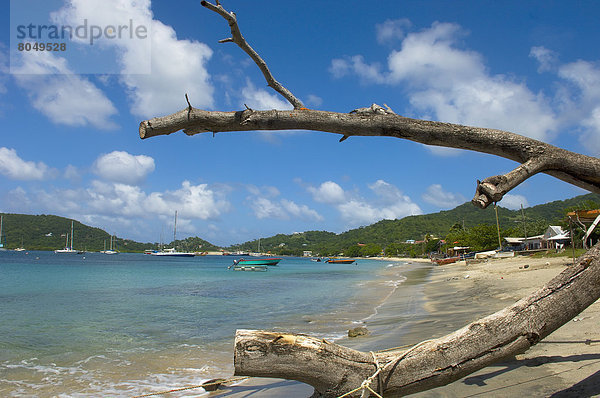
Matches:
[93,151,154,185]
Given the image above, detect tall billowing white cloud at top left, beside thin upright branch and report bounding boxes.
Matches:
[54,0,214,117]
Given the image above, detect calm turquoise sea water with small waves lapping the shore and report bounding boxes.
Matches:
[0,252,420,397]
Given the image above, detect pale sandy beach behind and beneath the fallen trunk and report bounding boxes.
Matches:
[211,257,600,398]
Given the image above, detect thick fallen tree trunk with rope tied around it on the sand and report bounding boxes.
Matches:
[234,244,600,398]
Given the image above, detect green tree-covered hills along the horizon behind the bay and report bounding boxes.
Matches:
[0,194,600,256]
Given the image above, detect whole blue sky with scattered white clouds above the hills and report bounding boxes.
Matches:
[0,0,600,245]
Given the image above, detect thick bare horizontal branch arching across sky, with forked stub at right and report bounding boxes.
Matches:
[139,106,600,208]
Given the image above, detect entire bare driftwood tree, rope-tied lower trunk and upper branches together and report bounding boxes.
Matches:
[139,1,600,397]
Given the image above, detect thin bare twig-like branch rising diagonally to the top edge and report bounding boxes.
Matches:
[200,1,304,109]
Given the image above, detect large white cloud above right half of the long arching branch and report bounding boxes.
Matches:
[330,23,556,140]
